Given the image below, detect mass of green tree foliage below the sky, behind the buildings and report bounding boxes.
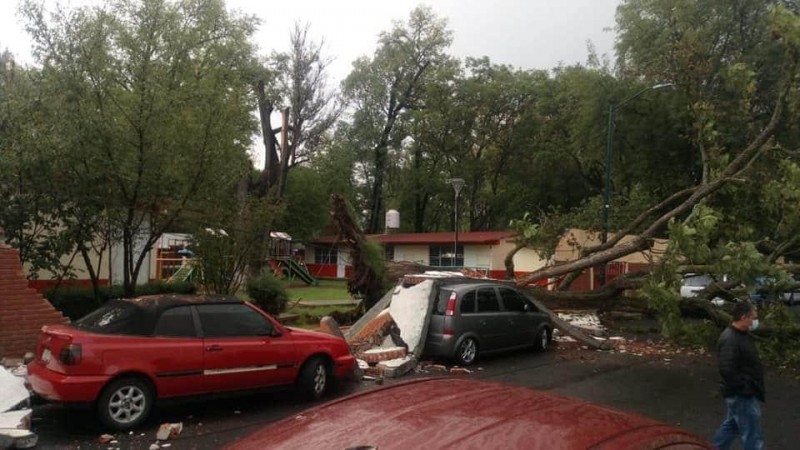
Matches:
[0,0,800,338]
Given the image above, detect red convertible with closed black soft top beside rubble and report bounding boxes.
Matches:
[28,295,355,430]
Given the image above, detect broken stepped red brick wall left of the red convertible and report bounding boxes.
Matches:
[0,245,69,358]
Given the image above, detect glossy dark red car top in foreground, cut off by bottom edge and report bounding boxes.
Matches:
[227,378,713,450]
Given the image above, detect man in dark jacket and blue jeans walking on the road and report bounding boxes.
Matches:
[712,301,764,450]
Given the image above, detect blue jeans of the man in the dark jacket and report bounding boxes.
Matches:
[711,396,764,450]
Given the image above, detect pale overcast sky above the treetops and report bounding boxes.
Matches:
[0,0,620,82]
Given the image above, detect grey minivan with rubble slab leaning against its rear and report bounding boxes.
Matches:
[423,280,553,365]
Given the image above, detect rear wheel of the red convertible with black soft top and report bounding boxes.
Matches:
[97,377,154,431]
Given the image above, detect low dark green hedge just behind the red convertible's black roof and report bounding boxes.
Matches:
[44,281,197,320]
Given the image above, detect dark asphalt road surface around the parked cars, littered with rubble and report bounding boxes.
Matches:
[28,342,800,450]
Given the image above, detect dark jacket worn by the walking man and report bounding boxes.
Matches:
[717,326,764,402]
